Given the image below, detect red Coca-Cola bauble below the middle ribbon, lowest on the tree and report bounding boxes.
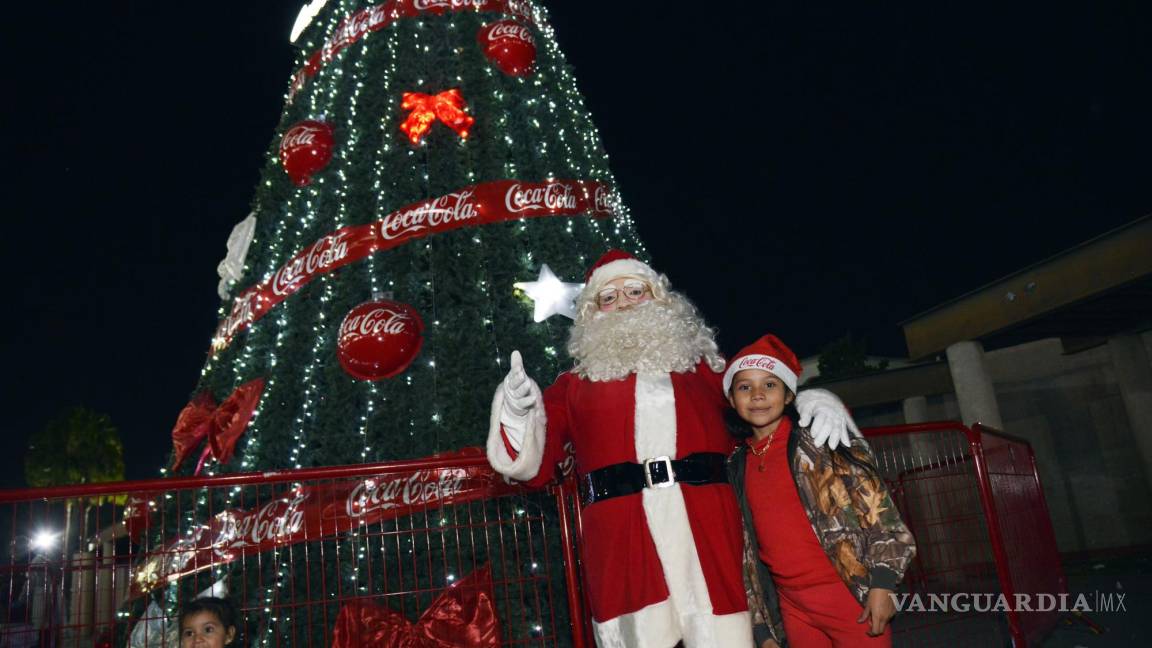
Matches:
[336,300,424,380]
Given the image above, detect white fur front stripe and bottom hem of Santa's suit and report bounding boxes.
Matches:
[622,374,752,648]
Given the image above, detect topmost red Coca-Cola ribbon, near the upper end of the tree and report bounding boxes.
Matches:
[288,0,533,104]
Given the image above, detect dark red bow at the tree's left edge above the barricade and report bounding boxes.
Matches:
[172,378,264,475]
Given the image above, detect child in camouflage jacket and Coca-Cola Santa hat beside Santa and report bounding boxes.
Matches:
[723,336,916,648]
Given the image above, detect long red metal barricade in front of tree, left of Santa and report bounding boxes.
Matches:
[0,452,588,647]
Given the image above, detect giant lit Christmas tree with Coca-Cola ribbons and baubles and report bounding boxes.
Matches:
[138,0,644,643]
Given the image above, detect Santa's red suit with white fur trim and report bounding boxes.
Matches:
[487,362,752,648]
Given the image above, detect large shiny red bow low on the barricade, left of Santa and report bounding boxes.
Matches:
[332,565,500,648]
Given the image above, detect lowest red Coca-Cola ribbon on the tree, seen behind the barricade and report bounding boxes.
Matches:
[129,449,518,597]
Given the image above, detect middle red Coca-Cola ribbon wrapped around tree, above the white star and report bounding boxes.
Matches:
[212,180,616,353]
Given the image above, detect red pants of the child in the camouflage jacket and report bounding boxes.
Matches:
[779,582,892,648]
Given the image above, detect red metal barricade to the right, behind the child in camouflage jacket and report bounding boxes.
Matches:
[863,422,1068,646]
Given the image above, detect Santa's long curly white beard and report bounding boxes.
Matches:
[568,293,725,380]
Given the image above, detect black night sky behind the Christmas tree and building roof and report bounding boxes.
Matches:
[0,0,1152,487]
